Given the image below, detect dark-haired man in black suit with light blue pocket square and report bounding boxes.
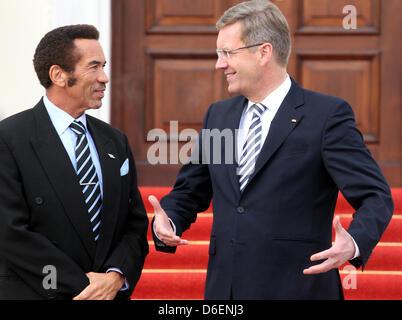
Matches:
[0,25,148,300]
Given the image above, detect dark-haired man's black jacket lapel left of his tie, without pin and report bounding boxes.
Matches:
[31,100,95,259]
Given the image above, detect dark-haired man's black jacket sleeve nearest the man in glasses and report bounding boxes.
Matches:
[104,136,149,296]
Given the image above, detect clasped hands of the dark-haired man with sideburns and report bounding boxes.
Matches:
[73,271,124,300]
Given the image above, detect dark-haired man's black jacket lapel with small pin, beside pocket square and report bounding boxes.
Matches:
[87,116,121,270]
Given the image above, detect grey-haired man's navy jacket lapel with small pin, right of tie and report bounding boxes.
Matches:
[243,79,304,191]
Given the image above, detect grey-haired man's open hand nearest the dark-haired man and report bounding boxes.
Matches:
[148,195,188,247]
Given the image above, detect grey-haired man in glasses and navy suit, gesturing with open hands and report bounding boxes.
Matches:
[149,1,393,299]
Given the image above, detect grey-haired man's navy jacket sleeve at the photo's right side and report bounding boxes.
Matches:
[322,102,393,268]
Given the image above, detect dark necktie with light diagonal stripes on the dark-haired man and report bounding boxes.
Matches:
[70,120,102,241]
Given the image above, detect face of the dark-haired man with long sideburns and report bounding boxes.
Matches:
[67,39,109,110]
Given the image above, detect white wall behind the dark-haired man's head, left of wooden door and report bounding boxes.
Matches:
[0,0,111,122]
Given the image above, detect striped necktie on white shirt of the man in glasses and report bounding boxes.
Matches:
[238,103,267,192]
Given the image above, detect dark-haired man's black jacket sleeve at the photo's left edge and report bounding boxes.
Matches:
[0,137,89,298]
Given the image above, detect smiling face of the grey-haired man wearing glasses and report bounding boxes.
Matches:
[215,22,261,97]
